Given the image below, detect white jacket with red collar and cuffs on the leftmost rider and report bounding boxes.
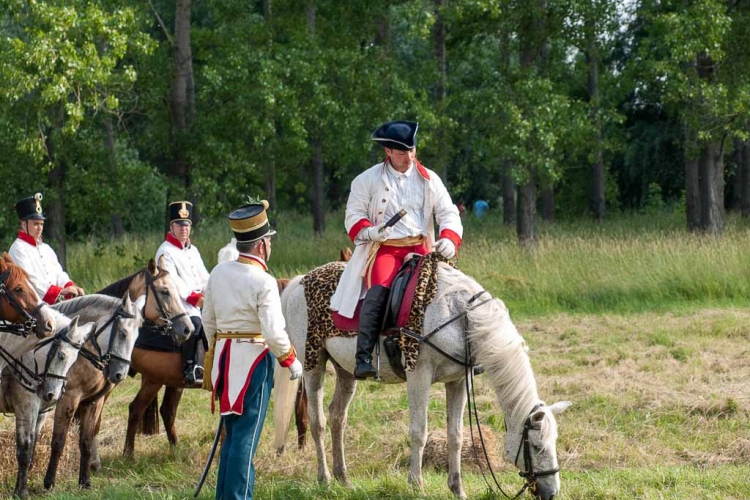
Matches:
[8,231,75,304]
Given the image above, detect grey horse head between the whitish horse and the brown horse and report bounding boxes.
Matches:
[97,292,143,384]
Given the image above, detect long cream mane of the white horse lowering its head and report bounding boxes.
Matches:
[438,263,546,436]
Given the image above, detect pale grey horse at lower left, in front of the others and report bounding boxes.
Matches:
[0,317,94,498]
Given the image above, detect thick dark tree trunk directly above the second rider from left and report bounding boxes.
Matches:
[168,0,195,192]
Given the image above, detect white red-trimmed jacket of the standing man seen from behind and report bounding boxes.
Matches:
[203,254,295,415]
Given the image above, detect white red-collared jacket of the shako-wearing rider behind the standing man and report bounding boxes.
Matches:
[156,233,208,317]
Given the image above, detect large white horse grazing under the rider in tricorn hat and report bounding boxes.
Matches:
[274,263,570,500]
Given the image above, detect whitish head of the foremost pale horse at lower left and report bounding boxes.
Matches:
[34,316,95,403]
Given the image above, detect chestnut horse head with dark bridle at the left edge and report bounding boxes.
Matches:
[0,253,55,339]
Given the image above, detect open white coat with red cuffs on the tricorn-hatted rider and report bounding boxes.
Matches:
[331,161,463,318]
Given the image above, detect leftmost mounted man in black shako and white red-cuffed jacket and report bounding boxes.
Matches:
[8,193,84,304]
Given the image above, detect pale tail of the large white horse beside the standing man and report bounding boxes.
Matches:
[273,276,304,455]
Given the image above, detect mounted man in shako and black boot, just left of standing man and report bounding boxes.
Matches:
[156,201,208,387]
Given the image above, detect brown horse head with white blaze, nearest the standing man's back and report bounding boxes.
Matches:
[143,256,195,343]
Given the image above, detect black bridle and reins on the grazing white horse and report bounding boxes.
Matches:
[401,290,560,500]
